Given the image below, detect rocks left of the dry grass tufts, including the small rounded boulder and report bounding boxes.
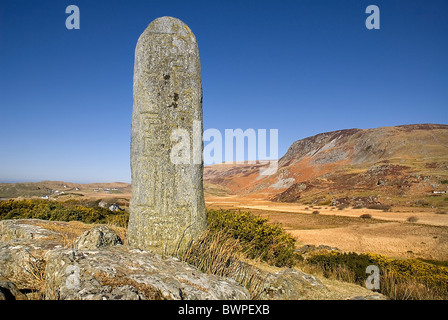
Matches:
[0,220,249,300]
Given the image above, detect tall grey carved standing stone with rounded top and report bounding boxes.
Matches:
[128,17,206,254]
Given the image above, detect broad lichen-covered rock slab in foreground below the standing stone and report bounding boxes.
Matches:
[45,246,249,300]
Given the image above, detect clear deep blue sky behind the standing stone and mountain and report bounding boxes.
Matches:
[0,0,448,183]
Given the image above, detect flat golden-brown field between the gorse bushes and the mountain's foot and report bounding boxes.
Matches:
[206,196,448,260]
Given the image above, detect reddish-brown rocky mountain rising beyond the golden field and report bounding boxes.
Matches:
[204,124,448,206]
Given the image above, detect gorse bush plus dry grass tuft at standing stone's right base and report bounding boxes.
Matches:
[180,210,301,299]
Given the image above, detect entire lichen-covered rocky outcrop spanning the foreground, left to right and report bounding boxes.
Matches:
[0,219,383,300]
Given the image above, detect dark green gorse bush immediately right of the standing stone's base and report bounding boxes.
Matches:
[207,210,295,267]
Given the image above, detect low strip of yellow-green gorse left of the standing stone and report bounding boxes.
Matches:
[0,199,128,225]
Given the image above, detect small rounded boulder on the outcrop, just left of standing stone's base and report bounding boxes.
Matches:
[73,226,123,250]
